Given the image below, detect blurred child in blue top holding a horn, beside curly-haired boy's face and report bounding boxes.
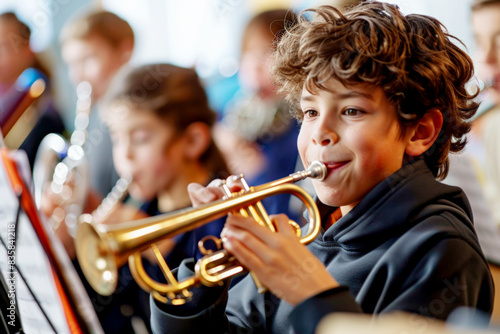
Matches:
[215,9,301,221]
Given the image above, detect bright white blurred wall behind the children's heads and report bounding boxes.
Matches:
[0,0,480,126]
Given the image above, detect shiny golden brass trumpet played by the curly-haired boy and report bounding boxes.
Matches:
[76,161,326,304]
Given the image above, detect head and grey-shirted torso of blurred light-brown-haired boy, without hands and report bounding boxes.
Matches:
[61,11,134,197]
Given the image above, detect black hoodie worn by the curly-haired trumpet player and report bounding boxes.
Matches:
[148,161,494,333]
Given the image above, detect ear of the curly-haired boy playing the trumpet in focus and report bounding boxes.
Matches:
[405,108,443,157]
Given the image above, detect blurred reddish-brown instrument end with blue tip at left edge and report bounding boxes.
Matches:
[0,68,47,137]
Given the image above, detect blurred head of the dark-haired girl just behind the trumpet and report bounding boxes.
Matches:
[103,64,228,264]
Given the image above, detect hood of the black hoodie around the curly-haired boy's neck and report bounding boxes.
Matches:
[319,161,477,249]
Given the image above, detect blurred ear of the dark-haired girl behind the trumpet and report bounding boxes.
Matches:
[183,122,212,160]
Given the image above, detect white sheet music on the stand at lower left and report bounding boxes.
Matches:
[0,152,70,334]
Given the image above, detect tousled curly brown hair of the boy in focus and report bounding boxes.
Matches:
[272,1,478,178]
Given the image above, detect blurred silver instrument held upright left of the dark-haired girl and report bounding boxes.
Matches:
[33,82,92,236]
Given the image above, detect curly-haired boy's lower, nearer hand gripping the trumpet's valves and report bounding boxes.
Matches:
[221,214,338,305]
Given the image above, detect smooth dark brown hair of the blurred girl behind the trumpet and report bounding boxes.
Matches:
[102,64,229,178]
